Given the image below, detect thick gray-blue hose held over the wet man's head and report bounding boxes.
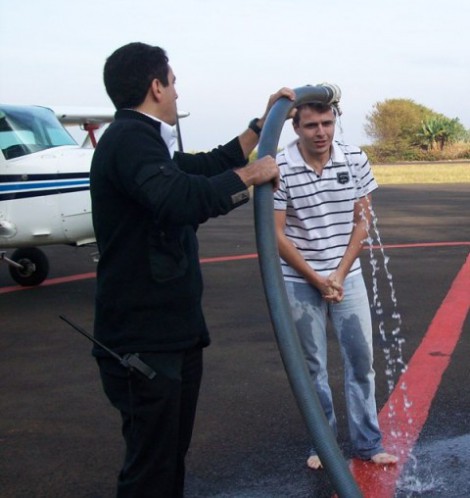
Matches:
[254,84,362,498]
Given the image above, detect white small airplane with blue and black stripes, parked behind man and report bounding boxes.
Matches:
[0,104,188,286]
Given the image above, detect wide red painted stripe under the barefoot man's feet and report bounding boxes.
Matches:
[351,256,470,498]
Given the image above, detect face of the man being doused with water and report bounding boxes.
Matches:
[294,107,335,156]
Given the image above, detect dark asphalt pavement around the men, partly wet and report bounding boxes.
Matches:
[0,184,470,498]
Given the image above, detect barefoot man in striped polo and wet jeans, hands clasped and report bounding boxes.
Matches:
[274,103,397,469]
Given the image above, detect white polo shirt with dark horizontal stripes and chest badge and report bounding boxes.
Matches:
[274,140,377,282]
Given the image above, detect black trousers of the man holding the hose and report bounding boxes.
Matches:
[98,348,202,498]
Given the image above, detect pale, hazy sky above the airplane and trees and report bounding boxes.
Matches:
[0,0,470,151]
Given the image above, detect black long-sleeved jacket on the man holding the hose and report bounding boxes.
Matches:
[90,110,249,356]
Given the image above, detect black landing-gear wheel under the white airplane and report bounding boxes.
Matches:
[9,247,49,287]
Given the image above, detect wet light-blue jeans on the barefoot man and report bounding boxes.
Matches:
[286,274,384,459]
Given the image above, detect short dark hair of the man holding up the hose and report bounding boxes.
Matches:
[103,42,169,109]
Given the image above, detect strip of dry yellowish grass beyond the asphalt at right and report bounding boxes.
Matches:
[372,161,470,185]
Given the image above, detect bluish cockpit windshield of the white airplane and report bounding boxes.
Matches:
[0,105,77,159]
